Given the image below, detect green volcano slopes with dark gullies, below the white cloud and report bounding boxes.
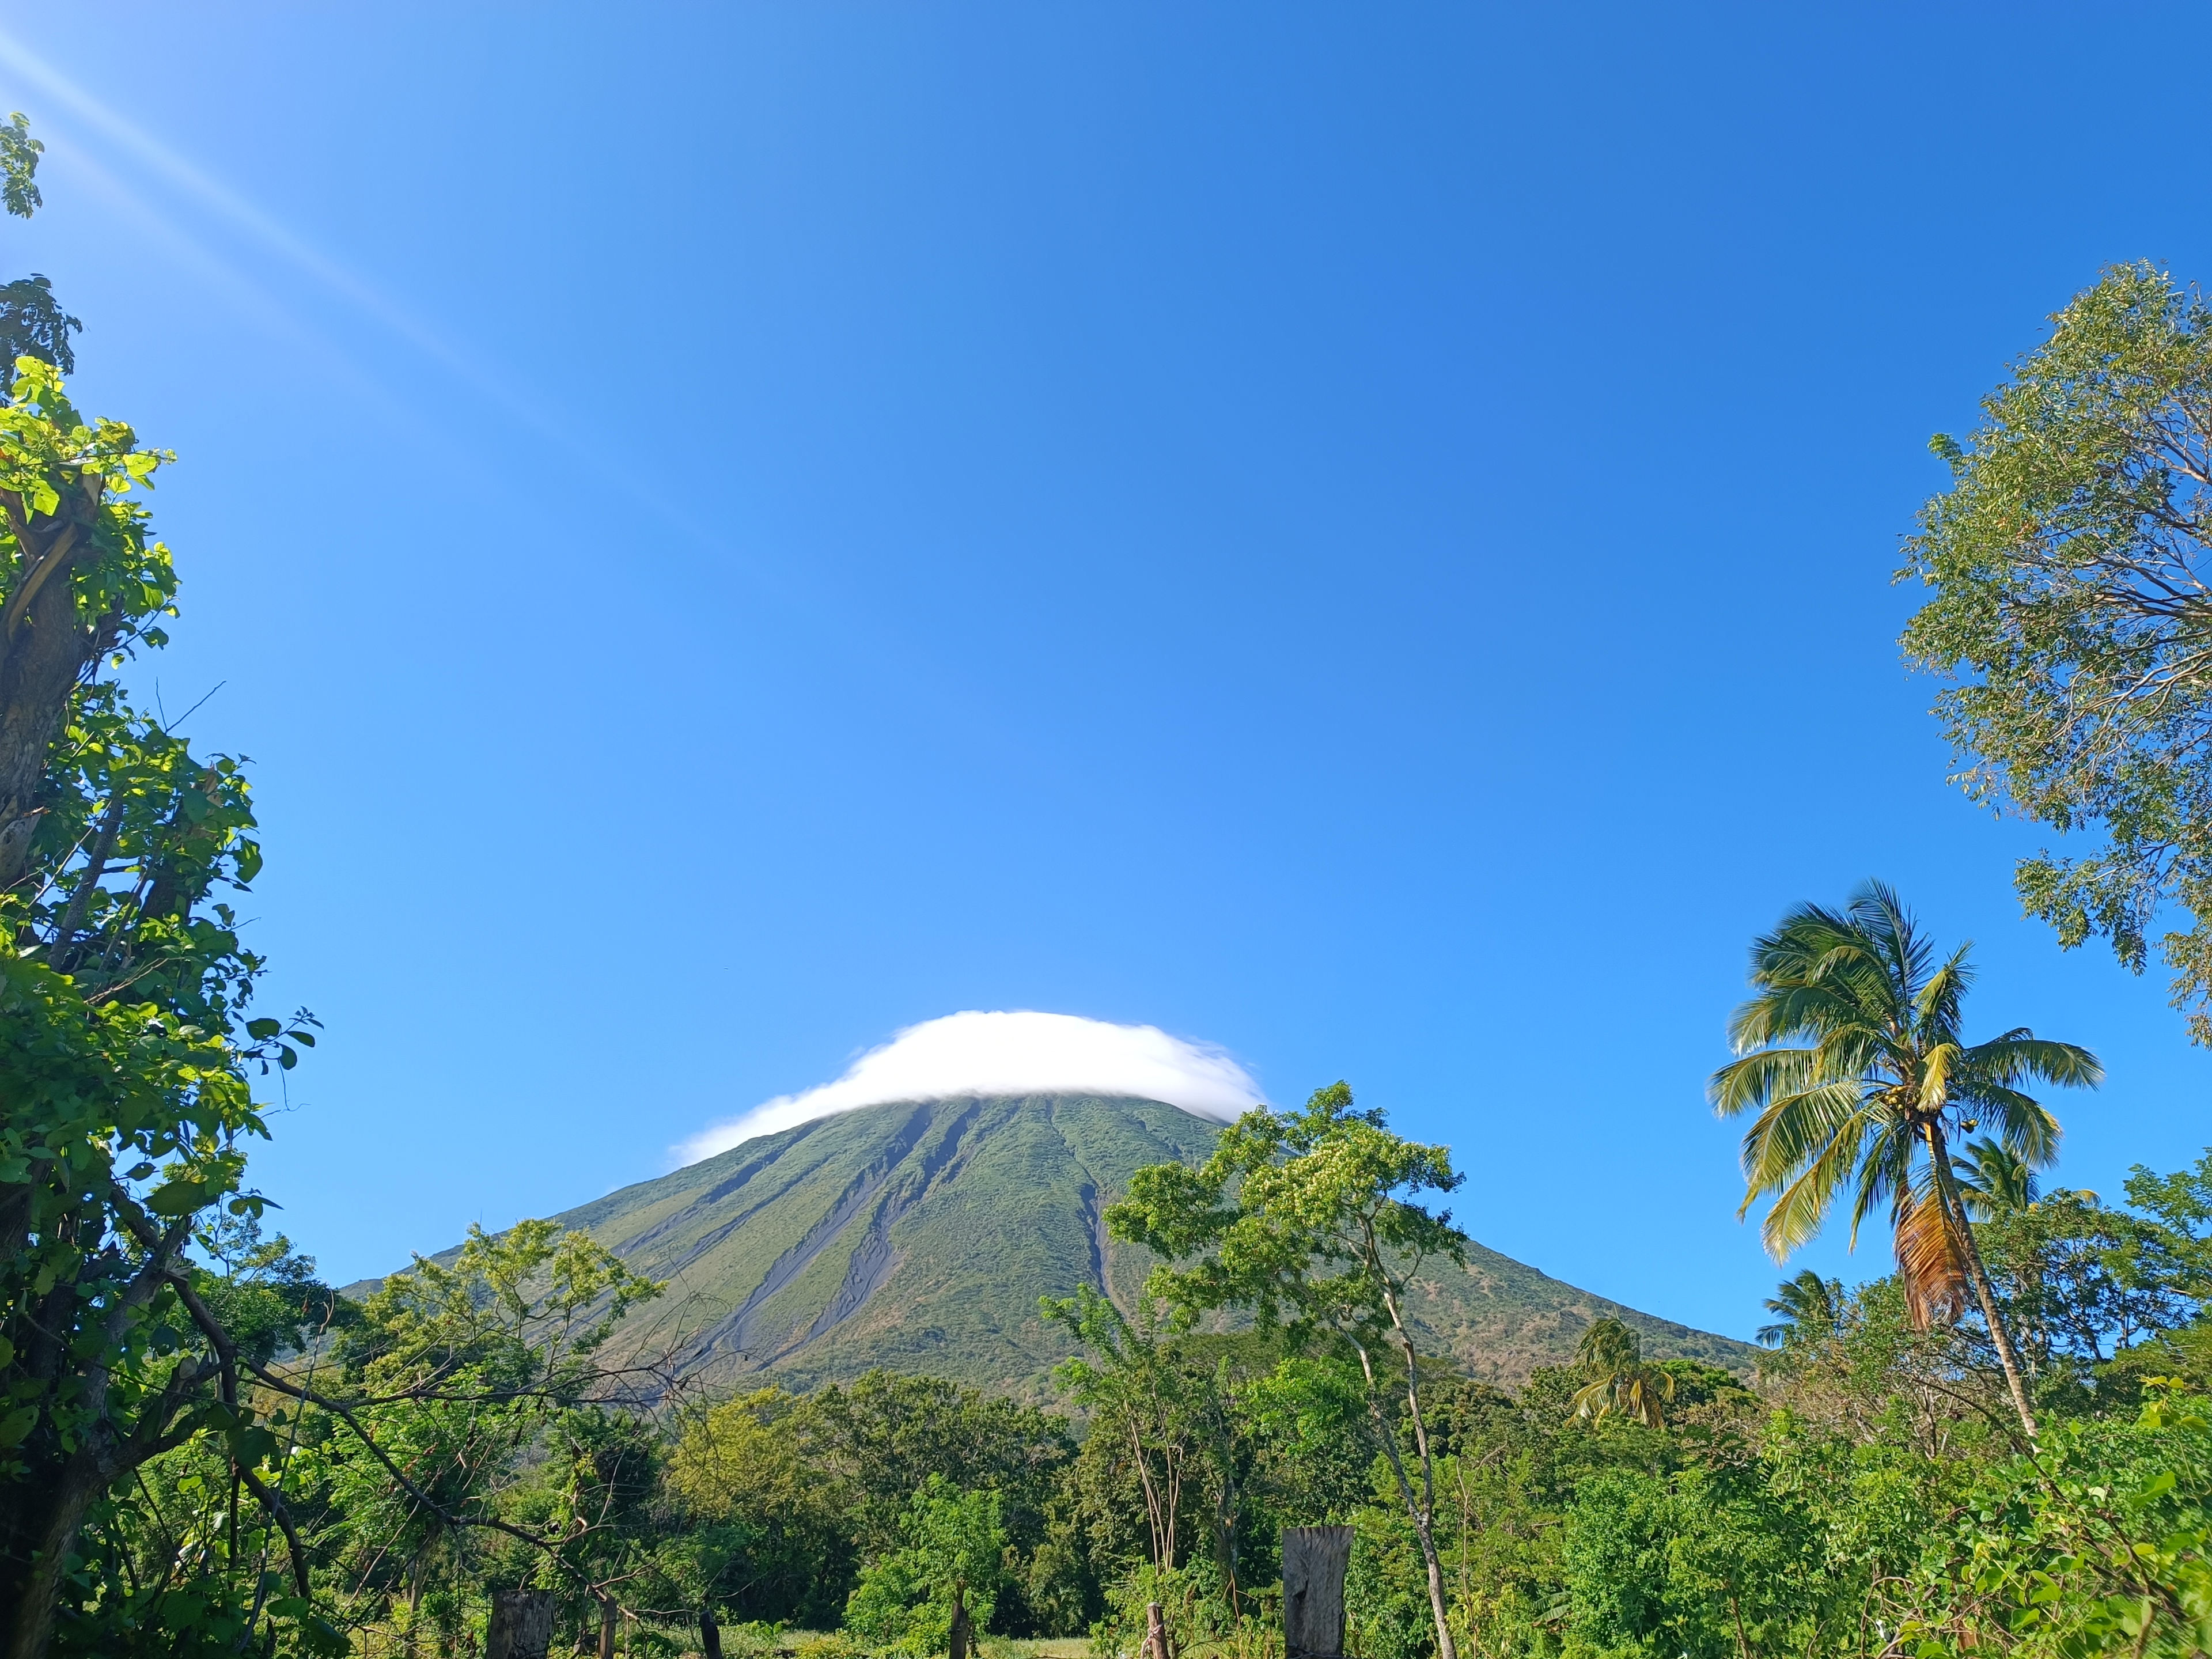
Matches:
[544,1095,1752,1391]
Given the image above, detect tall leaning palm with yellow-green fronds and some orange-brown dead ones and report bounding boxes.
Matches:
[1710,882,2104,1440]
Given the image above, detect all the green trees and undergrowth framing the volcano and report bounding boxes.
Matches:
[13,126,2212,1659]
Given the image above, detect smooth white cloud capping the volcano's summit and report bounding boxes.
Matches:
[677,1011,1261,1164]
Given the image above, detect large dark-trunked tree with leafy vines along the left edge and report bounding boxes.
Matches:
[0,360,327,1659]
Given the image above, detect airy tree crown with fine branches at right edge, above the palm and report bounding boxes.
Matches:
[1900,266,2212,1042]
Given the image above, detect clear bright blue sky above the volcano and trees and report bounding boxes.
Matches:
[0,5,2212,1334]
